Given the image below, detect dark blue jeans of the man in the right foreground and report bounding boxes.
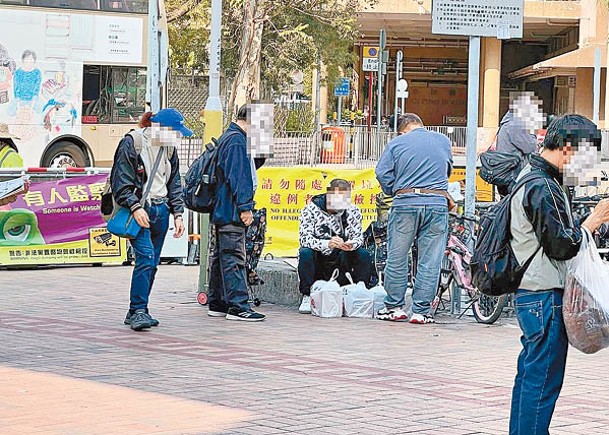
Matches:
[510,289,569,435]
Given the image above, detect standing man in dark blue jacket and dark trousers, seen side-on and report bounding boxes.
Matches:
[208,106,265,322]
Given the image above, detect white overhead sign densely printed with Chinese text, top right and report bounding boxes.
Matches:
[431,0,524,39]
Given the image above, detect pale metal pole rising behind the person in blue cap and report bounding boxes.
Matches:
[146,0,161,113]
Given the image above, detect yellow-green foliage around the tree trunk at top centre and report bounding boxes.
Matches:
[166,0,376,94]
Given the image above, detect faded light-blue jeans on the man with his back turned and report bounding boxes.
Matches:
[385,205,448,314]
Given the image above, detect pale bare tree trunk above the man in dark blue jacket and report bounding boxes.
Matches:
[227,0,265,116]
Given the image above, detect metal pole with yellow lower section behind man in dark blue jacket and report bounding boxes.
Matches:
[199,0,223,292]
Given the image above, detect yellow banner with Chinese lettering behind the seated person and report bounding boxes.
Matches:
[255,167,492,257]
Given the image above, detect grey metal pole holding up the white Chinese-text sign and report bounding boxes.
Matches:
[452,36,480,314]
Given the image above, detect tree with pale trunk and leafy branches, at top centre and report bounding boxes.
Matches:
[227,0,374,117]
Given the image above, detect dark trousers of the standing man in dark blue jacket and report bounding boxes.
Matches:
[208,224,252,311]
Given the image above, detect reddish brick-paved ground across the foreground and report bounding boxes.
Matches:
[0,266,609,435]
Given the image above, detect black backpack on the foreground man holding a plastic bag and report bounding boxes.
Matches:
[470,172,541,296]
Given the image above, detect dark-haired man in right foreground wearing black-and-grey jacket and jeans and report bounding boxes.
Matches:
[510,115,609,435]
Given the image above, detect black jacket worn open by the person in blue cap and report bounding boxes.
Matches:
[110,135,184,216]
